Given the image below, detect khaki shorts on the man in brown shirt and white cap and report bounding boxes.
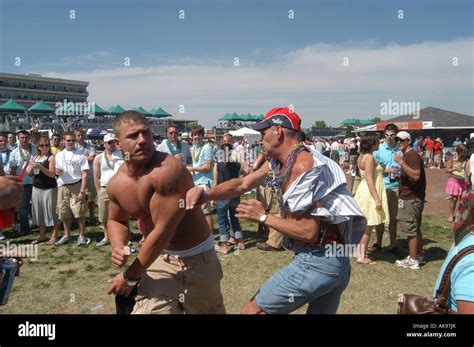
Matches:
[397,199,424,237]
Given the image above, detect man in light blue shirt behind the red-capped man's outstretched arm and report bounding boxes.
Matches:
[188,126,214,234]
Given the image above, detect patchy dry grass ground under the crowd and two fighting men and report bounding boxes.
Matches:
[0,209,453,314]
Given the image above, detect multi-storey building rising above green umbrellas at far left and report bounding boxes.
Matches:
[0,73,89,108]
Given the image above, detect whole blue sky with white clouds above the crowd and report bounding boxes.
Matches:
[0,0,474,126]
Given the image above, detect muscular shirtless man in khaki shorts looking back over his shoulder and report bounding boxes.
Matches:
[107,111,225,314]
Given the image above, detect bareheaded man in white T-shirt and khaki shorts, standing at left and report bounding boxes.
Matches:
[55,132,90,246]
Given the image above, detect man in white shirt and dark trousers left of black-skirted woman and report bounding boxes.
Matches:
[10,130,37,235]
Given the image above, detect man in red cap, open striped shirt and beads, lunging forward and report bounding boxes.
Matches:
[186,108,366,314]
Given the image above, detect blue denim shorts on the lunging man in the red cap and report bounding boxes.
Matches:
[255,248,351,314]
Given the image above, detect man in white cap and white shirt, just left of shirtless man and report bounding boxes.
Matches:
[93,133,123,247]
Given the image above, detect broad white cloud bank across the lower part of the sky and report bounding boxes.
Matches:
[42,37,474,126]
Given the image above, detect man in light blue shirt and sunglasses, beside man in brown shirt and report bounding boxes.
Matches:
[369,124,402,255]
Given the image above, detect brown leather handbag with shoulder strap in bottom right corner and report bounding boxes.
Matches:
[398,246,474,314]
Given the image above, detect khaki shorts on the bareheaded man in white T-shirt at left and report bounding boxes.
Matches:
[56,182,87,221]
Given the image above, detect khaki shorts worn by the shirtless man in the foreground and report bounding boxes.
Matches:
[132,249,225,314]
